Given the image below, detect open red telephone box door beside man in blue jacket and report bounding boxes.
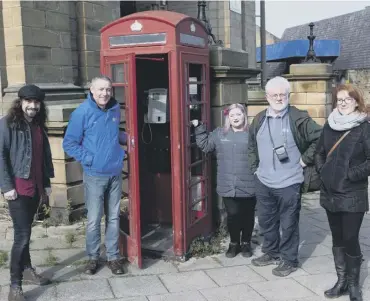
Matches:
[104,54,142,268]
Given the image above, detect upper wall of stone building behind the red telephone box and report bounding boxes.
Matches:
[0,0,256,115]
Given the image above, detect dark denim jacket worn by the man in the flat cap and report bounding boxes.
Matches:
[0,116,54,193]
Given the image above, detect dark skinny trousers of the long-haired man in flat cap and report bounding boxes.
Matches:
[8,195,39,285]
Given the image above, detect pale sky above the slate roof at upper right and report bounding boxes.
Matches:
[256,0,370,38]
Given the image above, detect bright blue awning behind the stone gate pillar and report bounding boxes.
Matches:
[256,40,340,63]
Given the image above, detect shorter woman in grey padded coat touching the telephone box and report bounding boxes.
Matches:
[192,104,256,258]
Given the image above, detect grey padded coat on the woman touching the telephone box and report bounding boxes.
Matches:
[195,125,255,197]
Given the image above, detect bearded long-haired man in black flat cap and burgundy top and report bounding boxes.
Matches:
[0,85,54,301]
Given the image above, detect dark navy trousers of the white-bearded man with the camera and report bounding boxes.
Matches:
[256,177,301,266]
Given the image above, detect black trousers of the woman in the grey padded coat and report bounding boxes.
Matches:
[223,197,256,243]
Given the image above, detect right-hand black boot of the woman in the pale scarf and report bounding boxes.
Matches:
[346,254,363,301]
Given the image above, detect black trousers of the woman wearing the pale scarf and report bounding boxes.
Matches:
[326,210,365,256]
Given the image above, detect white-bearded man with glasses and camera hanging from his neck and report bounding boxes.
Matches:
[248,77,321,277]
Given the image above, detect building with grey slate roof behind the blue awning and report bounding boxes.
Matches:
[268,6,370,103]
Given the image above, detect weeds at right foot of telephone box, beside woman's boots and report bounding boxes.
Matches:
[189,228,228,258]
